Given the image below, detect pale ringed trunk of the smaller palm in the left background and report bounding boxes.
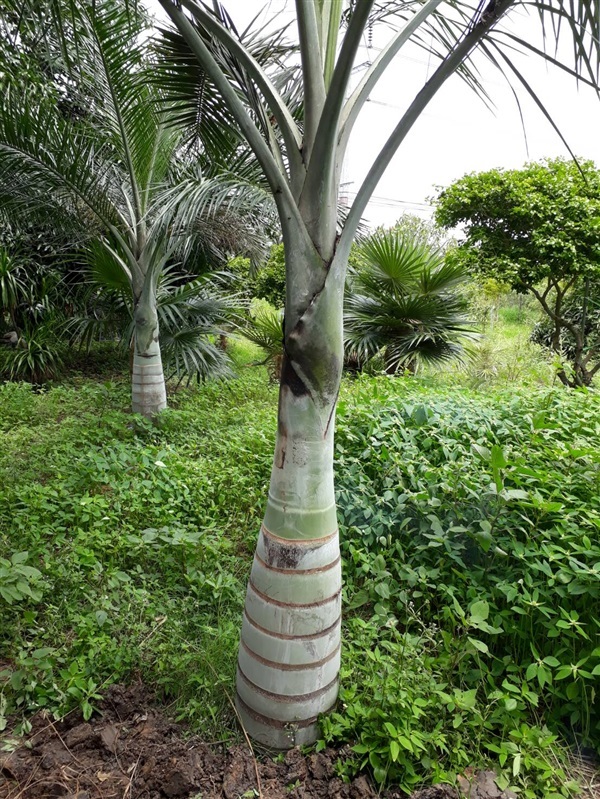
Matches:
[131,288,167,418]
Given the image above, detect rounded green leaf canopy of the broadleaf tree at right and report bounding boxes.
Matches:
[436,158,600,291]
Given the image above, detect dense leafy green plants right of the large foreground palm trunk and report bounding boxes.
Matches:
[329,379,600,797]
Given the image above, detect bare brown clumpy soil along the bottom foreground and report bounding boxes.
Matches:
[0,685,584,799]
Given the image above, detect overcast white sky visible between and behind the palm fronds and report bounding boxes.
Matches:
[146,0,600,224]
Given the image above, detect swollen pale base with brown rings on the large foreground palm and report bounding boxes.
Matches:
[236,526,341,749]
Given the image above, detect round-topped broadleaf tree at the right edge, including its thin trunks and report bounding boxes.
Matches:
[436,158,600,386]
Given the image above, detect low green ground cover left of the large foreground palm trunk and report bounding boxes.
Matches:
[0,336,276,734]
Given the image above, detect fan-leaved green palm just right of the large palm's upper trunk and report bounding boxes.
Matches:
[344,229,474,374]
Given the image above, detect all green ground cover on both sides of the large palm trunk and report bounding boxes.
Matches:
[0,328,600,799]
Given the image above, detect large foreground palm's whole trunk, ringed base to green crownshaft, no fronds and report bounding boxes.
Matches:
[237,252,343,749]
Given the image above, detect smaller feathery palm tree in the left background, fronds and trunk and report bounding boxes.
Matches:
[0,0,274,417]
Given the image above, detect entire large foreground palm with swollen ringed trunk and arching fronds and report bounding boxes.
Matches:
[160,0,600,747]
